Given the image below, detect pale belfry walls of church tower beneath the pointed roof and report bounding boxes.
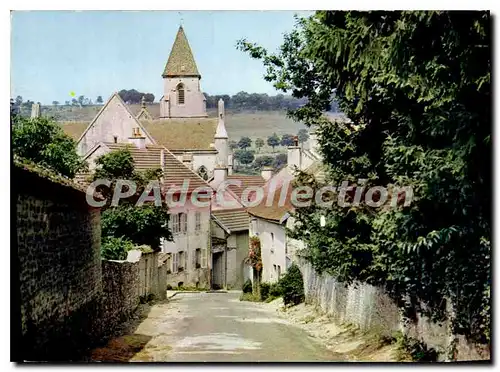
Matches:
[162,77,207,117]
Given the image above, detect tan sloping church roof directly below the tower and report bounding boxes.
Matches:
[141,118,218,152]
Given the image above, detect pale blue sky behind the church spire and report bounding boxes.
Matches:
[11,11,310,104]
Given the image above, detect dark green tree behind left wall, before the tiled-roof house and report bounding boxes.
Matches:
[93,149,172,250]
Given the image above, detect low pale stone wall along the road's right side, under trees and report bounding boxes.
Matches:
[298,260,490,360]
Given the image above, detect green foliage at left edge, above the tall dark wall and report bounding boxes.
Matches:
[11,115,86,178]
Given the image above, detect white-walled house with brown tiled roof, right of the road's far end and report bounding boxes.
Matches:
[247,133,325,282]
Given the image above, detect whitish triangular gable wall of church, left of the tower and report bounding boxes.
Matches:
[78,96,152,156]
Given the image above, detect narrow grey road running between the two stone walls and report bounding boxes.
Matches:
[93,292,344,362]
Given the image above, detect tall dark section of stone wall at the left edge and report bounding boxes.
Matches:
[12,167,102,360]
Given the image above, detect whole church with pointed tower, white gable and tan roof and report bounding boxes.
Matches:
[60,26,232,179]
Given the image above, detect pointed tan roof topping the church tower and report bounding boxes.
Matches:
[162,26,201,77]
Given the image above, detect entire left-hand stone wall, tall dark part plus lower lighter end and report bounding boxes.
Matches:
[11,166,167,361]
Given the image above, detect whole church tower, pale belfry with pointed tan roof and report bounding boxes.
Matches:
[160,26,207,118]
